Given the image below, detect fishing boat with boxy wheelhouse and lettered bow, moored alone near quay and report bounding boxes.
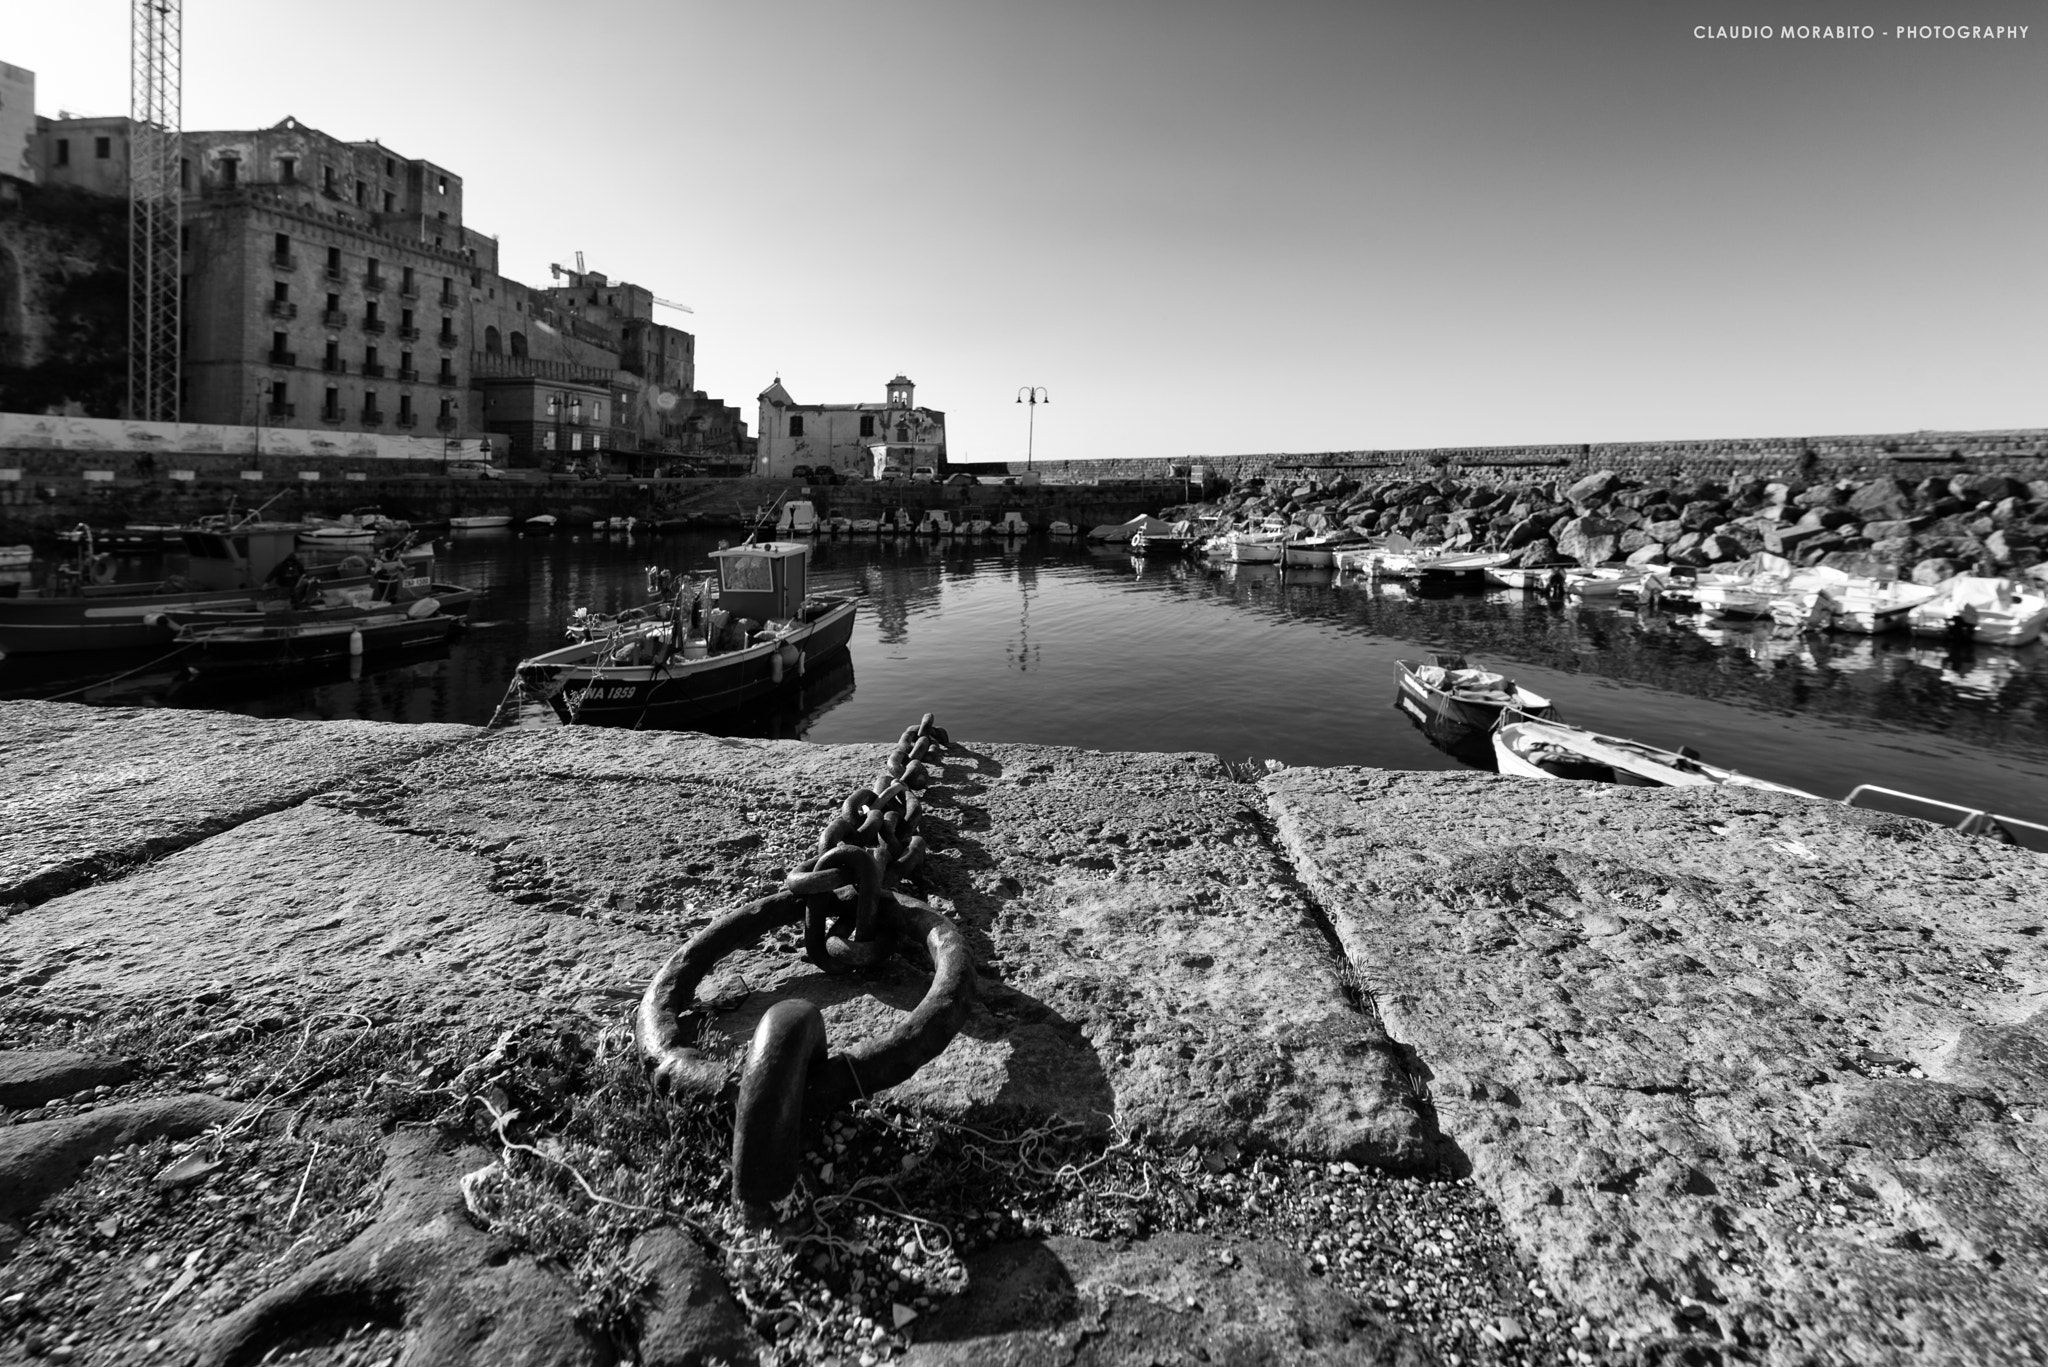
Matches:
[516,541,856,726]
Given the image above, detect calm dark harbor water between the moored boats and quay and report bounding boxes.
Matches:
[0,531,2048,842]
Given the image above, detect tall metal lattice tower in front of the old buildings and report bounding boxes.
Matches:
[129,0,184,422]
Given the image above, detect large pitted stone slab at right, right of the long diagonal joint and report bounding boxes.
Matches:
[1264,771,2048,1363]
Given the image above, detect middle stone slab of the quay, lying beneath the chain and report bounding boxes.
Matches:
[381,730,1432,1166]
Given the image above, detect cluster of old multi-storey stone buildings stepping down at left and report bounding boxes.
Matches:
[12,102,750,471]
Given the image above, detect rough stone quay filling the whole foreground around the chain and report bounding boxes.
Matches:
[0,703,2048,1365]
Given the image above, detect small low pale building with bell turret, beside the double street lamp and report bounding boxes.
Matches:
[754,375,946,480]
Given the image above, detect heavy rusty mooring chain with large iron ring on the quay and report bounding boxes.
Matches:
[635,713,975,1215]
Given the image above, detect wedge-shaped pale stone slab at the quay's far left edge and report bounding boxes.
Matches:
[0,703,481,904]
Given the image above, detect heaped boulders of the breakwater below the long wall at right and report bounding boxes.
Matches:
[1190,469,2048,584]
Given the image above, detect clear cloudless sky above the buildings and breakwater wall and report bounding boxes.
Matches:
[0,0,2048,461]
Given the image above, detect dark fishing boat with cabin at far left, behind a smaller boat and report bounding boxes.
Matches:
[0,523,410,656]
